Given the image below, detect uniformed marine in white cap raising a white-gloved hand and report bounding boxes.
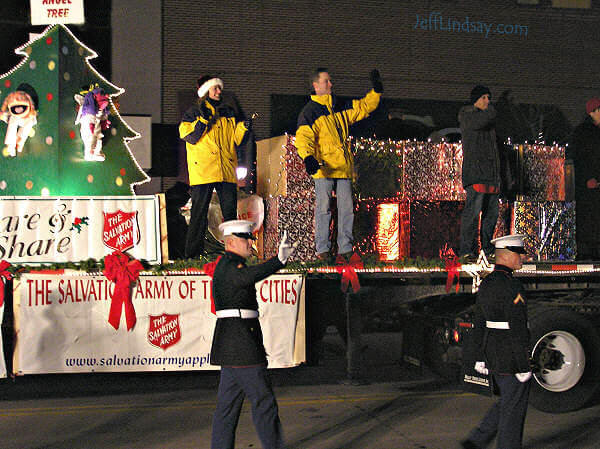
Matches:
[210,220,296,449]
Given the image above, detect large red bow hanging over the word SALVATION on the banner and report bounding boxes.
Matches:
[102,251,144,331]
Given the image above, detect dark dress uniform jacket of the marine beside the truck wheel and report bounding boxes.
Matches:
[473,265,531,374]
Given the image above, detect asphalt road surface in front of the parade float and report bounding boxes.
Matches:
[0,383,600,449]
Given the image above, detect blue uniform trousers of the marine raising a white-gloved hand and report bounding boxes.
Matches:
[211,365,284,449]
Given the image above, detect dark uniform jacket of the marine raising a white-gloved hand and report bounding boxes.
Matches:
[210,252,283,366]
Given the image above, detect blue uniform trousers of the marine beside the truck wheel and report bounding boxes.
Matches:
[468,374,530,449]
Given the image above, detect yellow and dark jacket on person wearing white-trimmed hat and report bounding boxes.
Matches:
[179,101,248,185]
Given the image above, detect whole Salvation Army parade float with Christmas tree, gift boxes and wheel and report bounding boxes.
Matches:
[0,15,600,411]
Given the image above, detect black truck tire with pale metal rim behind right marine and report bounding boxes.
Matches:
[530,309,600,413]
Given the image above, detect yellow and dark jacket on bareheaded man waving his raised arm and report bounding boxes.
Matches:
[296,90,381,179]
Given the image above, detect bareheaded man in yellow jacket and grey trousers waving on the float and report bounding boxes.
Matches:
[296,68,383,260]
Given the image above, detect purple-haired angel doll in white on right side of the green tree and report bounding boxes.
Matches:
[75,84,110,162]
